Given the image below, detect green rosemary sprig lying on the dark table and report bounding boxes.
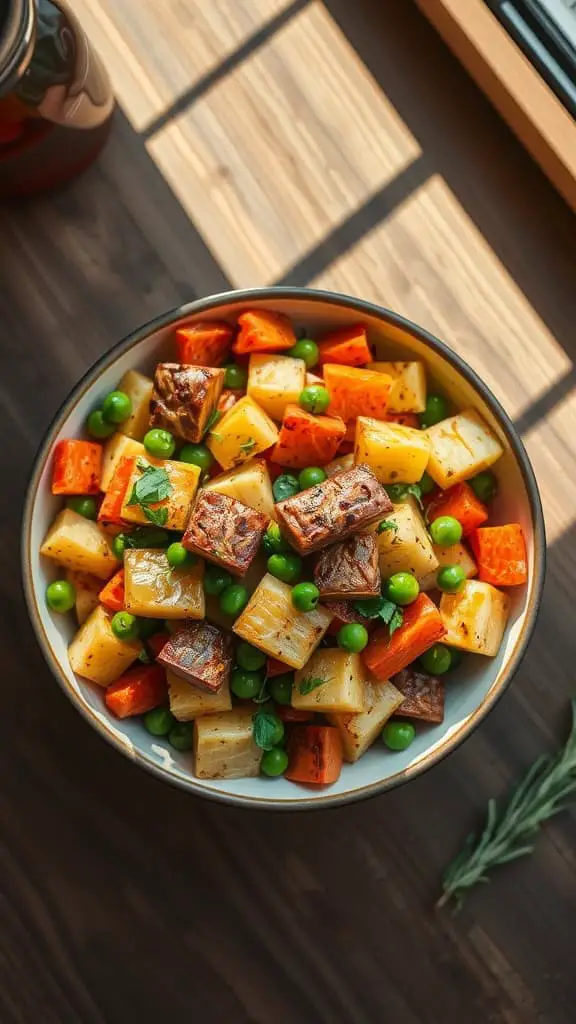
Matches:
[437,698,576,908]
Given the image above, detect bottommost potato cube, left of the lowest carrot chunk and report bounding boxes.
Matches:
[194,708,262,778]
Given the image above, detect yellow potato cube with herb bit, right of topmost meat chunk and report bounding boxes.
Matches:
[206,395,278,469]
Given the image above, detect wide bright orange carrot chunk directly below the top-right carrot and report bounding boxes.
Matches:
[324,362,394,423]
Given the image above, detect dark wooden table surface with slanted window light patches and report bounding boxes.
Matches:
[0,0,576,1024]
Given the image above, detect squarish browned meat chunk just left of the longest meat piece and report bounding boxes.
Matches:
[182,490,270,575]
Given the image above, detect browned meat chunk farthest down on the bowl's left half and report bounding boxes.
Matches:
[157,623,232,693]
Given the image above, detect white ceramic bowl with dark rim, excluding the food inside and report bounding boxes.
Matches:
[23,288,545,809]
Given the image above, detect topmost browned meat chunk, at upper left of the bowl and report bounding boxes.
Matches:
[150,362,224,441]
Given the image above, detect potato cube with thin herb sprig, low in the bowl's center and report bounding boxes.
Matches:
[292,647,368,712]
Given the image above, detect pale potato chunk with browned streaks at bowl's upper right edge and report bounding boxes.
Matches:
[422,409,503,488]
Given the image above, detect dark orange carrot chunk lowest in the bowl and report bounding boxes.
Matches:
[286,725,343,785]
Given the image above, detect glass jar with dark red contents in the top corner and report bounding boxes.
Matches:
[0,0,114,199]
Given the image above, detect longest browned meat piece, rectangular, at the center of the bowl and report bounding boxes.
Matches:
[276,466,393,555]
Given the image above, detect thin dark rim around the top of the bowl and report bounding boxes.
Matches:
[22,286,546,811]
